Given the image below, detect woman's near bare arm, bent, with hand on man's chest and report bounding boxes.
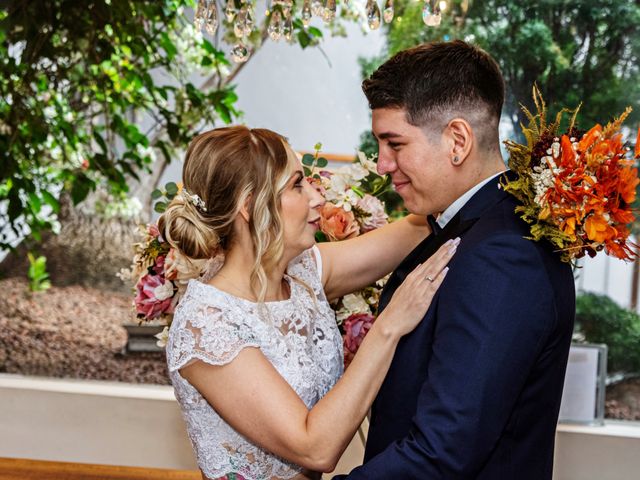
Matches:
[180,245,455,472]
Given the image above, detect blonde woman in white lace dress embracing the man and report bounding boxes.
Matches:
[159,126,457,480]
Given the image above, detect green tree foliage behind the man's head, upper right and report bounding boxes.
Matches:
[361,0,640,132]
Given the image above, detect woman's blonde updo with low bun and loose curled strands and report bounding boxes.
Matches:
[158,126,295,302]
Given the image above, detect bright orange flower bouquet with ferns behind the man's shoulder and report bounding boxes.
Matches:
[503,87,640,262]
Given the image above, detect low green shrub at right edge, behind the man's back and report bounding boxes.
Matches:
[576,293,640,373]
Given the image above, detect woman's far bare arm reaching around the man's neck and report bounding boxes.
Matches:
[318,215,431,300]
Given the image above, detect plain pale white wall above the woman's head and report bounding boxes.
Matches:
[160,24,385,185]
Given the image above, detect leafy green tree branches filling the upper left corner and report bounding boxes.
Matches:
[0,0,239,248]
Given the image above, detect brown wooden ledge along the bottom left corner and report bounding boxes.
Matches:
[0,458,202,480]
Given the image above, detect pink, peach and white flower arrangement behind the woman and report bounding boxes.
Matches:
[118,144,391,366]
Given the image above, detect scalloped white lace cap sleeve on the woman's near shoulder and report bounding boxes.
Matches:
[167,305,260,372]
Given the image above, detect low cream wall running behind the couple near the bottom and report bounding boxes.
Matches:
[0,374,640,480]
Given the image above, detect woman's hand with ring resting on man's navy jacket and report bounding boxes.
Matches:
[376,238,460,336]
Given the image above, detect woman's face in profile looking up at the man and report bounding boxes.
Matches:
[280,155,325,258]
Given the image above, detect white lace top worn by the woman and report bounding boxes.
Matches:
[167,247,343,480]
